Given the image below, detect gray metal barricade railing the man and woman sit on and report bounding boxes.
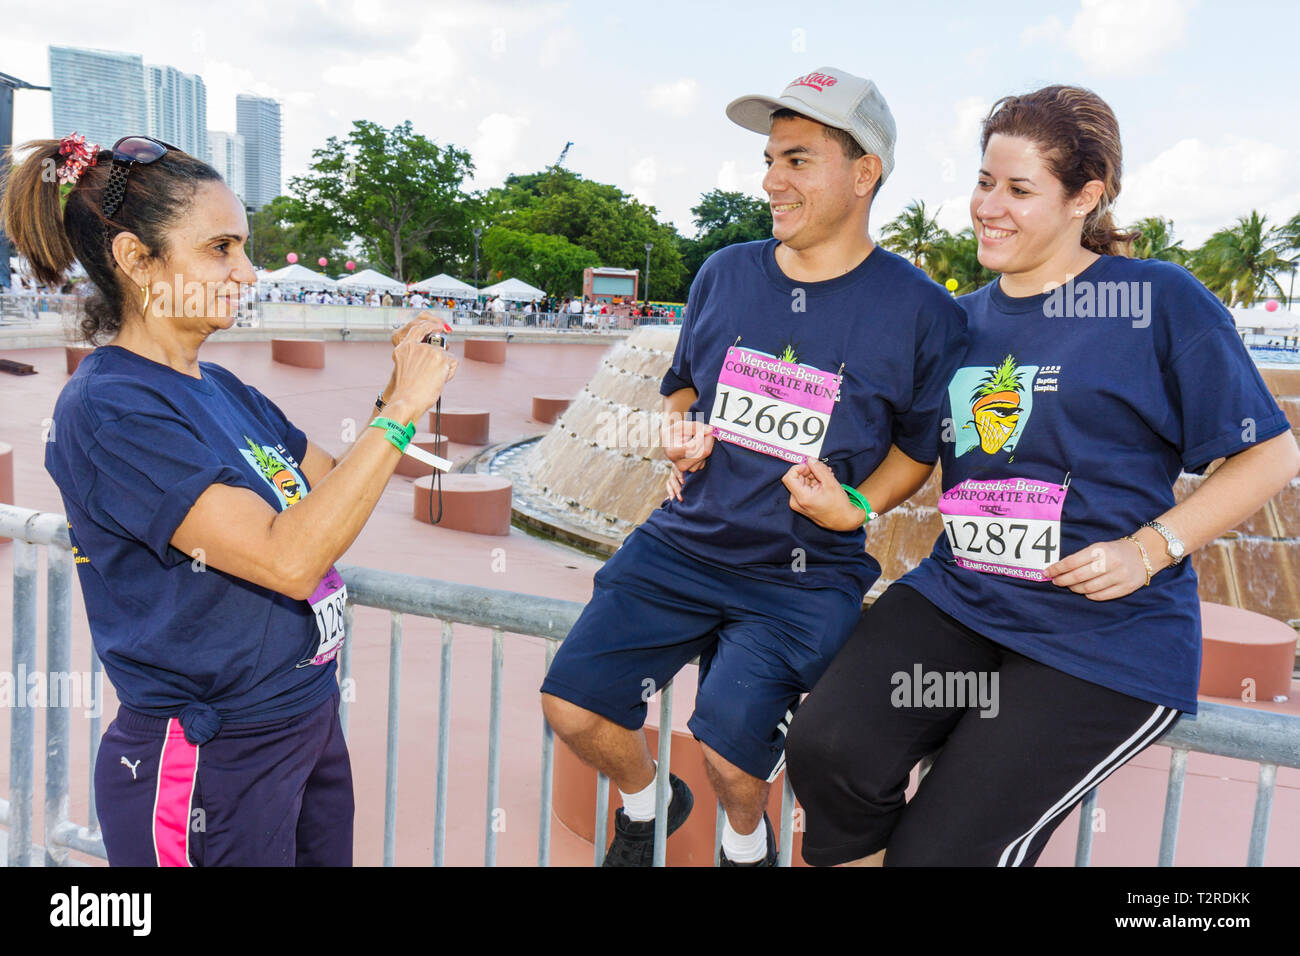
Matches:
[0,505,1300,866]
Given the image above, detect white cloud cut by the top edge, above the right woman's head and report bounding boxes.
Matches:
[1021,0,1191,74]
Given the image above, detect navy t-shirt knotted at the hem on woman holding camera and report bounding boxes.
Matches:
[46,346,335,743]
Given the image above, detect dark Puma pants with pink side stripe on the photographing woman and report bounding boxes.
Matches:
[95,693,354,866]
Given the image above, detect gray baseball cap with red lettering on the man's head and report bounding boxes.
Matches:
[727,66,897,182]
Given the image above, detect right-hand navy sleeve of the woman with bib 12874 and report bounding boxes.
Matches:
[1165,319,1291,475]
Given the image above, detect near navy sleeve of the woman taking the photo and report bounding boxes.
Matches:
[86,412,251,564]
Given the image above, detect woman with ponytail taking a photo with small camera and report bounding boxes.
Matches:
[0,135,455,866]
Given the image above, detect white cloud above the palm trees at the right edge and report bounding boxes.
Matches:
[1117,135,1300,247]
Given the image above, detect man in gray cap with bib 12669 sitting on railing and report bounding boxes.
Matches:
[542,68,965,866]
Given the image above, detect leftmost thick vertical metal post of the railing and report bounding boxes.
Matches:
[9,538,36,866]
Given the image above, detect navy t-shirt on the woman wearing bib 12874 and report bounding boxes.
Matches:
[900,256,1290,713]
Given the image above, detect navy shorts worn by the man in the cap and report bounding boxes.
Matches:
[542,529,862,779]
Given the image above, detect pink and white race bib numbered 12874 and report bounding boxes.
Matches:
[939,477,1069,581]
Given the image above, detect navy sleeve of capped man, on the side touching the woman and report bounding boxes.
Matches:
[891,302,966,464]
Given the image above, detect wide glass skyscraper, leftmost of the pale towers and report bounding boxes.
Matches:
[49,47,144,150]
